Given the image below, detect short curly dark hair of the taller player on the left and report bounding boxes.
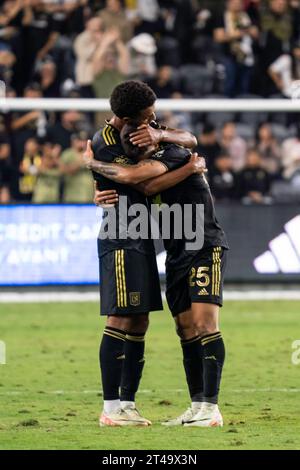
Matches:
[110,80,156,119]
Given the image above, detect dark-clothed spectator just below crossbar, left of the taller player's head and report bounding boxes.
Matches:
[47,110,83,150]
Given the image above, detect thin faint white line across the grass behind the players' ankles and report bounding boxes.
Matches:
[0,388,300,396]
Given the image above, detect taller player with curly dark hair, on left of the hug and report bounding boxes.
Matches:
[89,81,197,426]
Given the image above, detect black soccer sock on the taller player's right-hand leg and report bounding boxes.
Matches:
[121,333,145,401]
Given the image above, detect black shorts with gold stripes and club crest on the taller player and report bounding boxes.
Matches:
[99,249,163,315]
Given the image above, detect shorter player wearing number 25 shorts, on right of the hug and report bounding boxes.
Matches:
[88,123,228,427]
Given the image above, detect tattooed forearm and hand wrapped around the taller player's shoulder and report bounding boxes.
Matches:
[83,140,168,184]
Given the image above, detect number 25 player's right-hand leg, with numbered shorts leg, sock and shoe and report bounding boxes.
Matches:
[186,247,226,426]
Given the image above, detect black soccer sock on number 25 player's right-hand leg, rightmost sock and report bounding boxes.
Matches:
[201,331,225,404]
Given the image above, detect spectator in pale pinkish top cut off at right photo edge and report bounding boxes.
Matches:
[282,123,300,180]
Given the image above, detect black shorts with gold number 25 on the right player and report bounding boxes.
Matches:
[166,247,227,316]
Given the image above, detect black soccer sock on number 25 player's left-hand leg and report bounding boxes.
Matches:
[181,336,203,402]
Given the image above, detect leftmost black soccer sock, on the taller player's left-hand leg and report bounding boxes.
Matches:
[99,326,126,400]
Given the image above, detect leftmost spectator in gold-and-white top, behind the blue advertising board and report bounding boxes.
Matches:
[19,138,42,201]
